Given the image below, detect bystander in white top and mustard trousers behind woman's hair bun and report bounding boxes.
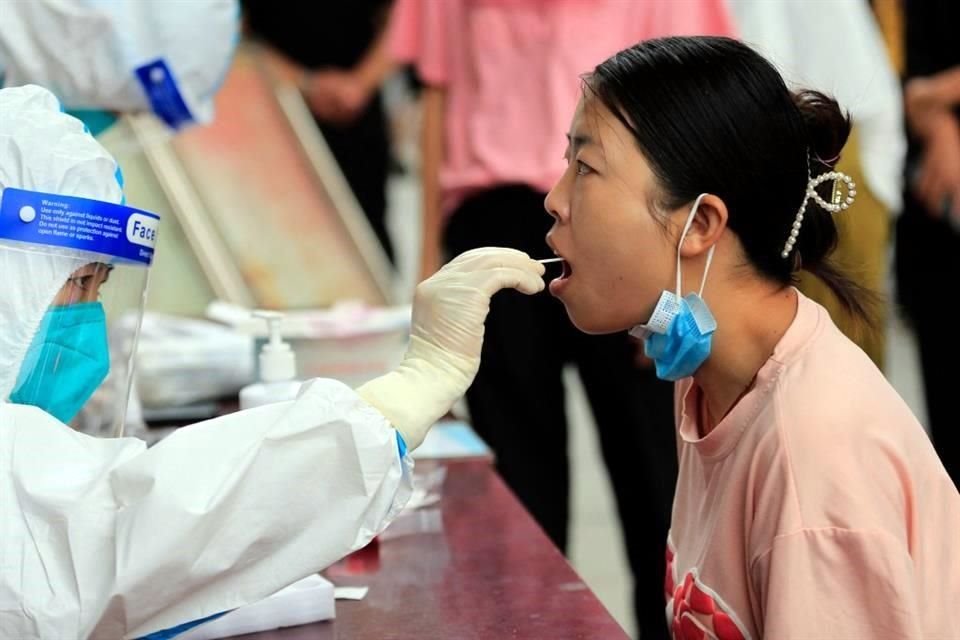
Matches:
[729,0,906,370]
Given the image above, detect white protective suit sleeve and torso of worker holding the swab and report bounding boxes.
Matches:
[0,380,411,640]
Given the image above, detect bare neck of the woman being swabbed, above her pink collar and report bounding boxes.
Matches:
[694,281,798,437]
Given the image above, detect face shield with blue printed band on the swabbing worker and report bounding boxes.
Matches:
[0,188,159,434]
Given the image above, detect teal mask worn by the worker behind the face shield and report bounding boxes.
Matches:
[10,302,110,423]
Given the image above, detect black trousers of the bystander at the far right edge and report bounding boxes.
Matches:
[896,202,960,487]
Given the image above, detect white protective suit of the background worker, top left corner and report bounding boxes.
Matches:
[0,0,240,127]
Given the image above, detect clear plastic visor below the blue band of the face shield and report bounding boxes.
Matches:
[0,241,149,435]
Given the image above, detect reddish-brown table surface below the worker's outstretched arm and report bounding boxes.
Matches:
[232,461,628,640]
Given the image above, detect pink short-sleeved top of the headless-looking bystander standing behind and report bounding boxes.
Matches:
[389,0,733,214]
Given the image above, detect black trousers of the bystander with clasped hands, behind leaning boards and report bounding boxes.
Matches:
[317,93,394,262]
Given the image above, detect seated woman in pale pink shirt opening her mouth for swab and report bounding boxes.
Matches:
[546,37,960,640]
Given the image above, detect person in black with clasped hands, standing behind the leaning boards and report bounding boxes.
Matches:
[248,0,402,261]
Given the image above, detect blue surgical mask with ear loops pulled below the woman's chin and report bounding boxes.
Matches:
[630,194,717,381]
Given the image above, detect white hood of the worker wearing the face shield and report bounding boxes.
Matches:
[0,83,123,401]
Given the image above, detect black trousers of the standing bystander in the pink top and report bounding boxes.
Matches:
[444,186,677,640]
